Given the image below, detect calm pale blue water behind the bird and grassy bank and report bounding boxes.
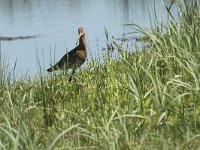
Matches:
[0,0,172,75]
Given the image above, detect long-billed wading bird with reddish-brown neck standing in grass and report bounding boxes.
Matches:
[47,27,87,75]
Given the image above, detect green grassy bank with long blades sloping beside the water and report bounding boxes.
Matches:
[0,0,200,149]
